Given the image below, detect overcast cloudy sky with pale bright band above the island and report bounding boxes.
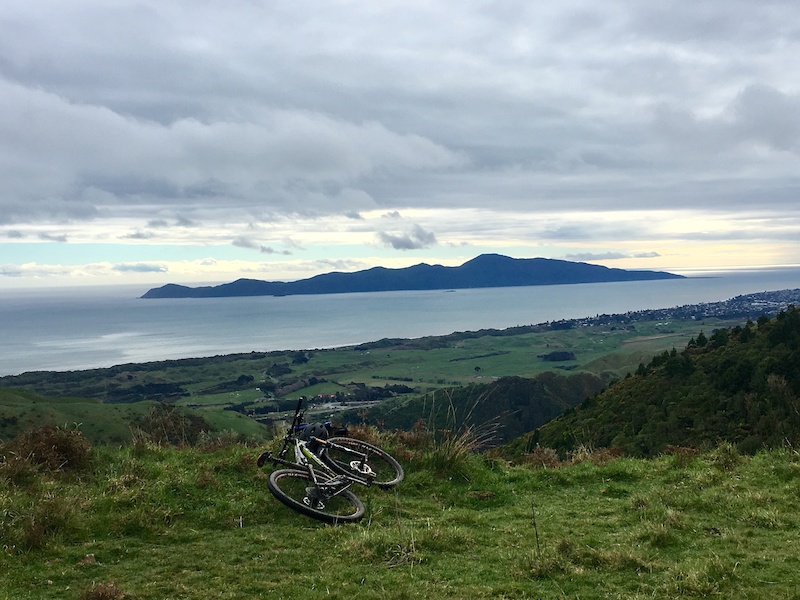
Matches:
[0,0,800,289]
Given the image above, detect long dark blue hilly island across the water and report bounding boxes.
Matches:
[142,254,683,298]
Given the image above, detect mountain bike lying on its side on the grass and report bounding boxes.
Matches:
[257,399,404,525]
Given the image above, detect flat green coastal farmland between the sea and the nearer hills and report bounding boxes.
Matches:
[0,319,737,443]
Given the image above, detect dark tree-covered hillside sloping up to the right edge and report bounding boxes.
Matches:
[509,306,800,456]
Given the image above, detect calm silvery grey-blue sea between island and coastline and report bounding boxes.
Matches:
[0,267,800,376]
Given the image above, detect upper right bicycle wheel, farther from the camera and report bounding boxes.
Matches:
[320,437,405,489]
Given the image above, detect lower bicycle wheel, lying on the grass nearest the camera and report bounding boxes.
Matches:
[267,469,364,525]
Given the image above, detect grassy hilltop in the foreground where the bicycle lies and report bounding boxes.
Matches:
[0,431,800,600]
